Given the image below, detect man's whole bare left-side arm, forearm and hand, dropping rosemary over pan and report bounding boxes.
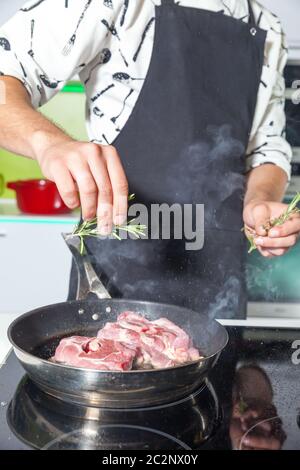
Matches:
[0,77,128,235]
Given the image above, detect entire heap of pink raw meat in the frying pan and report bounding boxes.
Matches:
[52,312,203,371]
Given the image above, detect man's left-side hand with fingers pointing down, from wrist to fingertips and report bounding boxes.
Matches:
[36,139,128,235]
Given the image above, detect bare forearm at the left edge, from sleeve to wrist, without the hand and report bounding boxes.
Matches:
[0,77,72,159]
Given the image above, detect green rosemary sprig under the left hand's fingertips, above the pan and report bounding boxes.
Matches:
[70,194,147,255]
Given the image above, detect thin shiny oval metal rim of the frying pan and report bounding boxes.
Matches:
[7,299,229,375]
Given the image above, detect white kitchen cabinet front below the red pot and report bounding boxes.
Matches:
[0,217,76,314]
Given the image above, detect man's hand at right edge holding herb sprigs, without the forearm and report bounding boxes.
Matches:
[243,200,300,258]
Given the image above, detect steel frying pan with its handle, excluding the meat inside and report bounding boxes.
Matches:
[8,235,228,408]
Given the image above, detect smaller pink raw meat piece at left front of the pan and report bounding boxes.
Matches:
[52,336,136,371]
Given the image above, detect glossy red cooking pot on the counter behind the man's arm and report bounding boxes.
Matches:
[6,179,71,215]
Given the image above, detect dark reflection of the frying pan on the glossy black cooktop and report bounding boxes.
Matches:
[7,375,221,450]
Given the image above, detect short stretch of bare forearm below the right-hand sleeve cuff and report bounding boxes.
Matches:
[244,164,287,206]
